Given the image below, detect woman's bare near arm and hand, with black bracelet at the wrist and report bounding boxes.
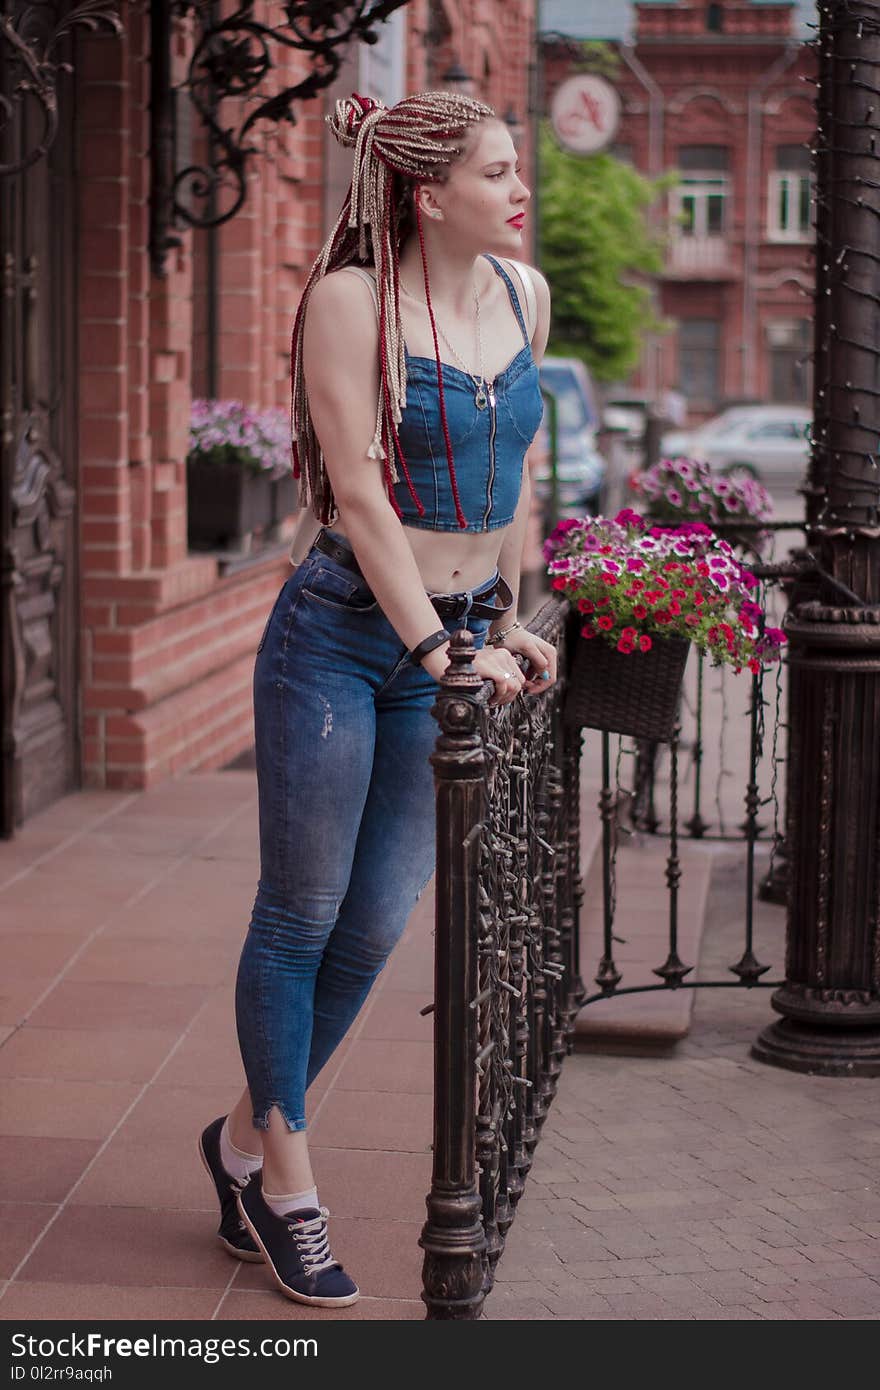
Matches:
[303,274,521,699]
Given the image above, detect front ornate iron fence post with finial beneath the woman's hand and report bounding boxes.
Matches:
[418,631,487,1319]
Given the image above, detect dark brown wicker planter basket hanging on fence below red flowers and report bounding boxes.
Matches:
[564,637,691,744]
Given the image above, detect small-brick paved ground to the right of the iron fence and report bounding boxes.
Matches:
[485,851,880,1321]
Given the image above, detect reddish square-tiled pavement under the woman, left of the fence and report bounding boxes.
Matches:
[0,771,432,1321]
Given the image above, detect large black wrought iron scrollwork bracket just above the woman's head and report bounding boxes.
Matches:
[152,0,407,274]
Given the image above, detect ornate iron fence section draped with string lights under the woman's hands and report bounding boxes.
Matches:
[420,600,582,1319]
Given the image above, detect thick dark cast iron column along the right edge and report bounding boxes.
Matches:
[752,0,880,1076]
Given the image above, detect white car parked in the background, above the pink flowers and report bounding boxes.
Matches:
[660,406,812,491]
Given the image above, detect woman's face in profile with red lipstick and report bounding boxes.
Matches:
[430,120,531,256]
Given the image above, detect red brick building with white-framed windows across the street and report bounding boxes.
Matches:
[544,0,815,418]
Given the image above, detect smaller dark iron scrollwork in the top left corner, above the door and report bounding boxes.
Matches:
[0,0,122,178]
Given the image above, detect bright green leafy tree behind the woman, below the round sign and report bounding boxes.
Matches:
[538,128,670,381]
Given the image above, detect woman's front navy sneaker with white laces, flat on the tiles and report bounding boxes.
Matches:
[238,1173,360,1308]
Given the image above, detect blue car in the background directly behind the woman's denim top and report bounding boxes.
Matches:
[534,357,606,513]
